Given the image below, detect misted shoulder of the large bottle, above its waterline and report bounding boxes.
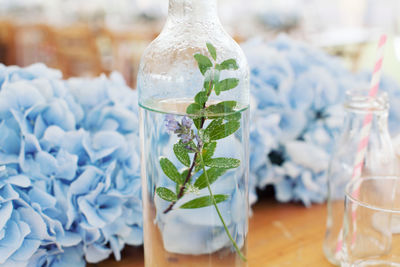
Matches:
[138,25,250,106]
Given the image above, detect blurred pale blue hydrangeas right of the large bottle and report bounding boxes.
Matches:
[243,35,400,206]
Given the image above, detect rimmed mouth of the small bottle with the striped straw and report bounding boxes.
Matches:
[344,89,389,112]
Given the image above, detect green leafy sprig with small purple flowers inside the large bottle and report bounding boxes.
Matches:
[156,43,246,261]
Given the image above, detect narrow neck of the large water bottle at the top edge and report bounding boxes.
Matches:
[167,0,219,24]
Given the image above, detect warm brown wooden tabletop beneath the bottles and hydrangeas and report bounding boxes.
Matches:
[91,198,332,267]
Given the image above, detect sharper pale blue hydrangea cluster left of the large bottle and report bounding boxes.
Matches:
[0,64,143,266]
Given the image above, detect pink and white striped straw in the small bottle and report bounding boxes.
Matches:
[336,34,387,254]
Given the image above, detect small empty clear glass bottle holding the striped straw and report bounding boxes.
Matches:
[323,90,397,265]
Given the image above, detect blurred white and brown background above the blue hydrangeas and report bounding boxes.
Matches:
[0,0,400,88]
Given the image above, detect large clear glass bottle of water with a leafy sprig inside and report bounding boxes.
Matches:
[138,0,249,267]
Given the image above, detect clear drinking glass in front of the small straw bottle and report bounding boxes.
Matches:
[341,176,400,267]
